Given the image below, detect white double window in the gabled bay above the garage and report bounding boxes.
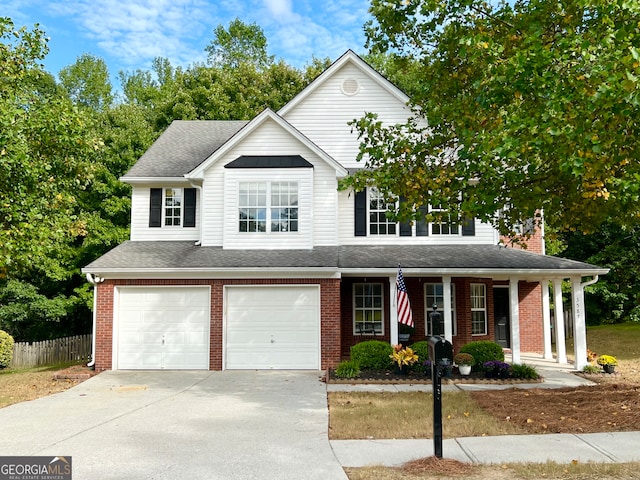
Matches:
[238,182,298,232]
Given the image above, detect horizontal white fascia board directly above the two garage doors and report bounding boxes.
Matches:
[82,267,340,280]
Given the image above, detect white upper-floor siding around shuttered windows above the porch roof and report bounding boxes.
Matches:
[338,191,496,245]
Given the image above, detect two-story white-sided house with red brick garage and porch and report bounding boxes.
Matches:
[83,51,606,370]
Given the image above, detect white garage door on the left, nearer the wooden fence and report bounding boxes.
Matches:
[114,287,210,370]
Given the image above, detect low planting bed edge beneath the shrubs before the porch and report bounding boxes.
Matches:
[325,369,544,385]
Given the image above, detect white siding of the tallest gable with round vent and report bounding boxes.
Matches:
[285,64,411,168]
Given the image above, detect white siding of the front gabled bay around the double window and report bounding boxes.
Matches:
[202,121,338,248]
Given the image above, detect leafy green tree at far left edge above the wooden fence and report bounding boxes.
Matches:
[0,18,99,280]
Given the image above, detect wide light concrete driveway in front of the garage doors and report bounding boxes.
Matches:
[0,371,347,480]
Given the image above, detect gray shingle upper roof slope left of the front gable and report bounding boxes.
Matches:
[122,120,249,180]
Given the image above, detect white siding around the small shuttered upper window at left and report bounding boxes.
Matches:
[131,185,201,242]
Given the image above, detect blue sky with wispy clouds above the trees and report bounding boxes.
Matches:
[6,0,369,84]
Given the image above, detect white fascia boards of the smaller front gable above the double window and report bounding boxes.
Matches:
[185,108,348,180]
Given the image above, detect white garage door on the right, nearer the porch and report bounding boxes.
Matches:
[225,285,320,370]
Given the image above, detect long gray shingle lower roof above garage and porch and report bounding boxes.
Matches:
[85,241,606,275]
